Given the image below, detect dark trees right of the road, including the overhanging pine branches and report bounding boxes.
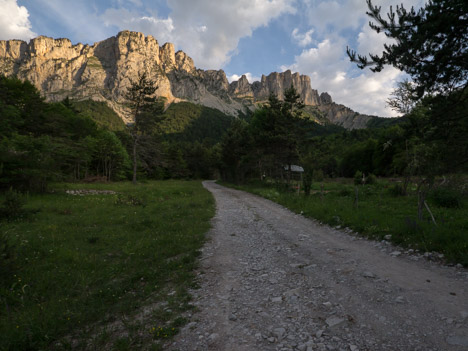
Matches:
[218,0,468,187]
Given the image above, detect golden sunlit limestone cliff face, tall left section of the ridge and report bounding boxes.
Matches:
[0,31,176,122]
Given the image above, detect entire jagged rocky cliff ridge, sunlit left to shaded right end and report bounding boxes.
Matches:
[0,31,378,129]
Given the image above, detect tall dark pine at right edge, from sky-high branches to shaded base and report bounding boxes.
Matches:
[347,0,468,178]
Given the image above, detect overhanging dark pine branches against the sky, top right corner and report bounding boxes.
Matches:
[347,0,468,99]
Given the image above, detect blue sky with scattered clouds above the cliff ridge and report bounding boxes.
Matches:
[0,0,424,117]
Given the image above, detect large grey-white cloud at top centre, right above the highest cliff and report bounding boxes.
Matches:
[102,0,295,69]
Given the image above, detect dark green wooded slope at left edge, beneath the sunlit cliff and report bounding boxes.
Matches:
[0,77,128,191]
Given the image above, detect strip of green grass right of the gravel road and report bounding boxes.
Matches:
[224,180,468,266]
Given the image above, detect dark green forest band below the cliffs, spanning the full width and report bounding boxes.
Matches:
[0,77,468,191]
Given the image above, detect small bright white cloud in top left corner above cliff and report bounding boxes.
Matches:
[0,0,37,40]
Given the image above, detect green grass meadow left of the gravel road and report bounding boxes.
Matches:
[0,181,214,350]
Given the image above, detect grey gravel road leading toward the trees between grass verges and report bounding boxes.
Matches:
[167,182,468,351]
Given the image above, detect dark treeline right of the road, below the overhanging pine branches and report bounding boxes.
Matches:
[221,88,468,186]
